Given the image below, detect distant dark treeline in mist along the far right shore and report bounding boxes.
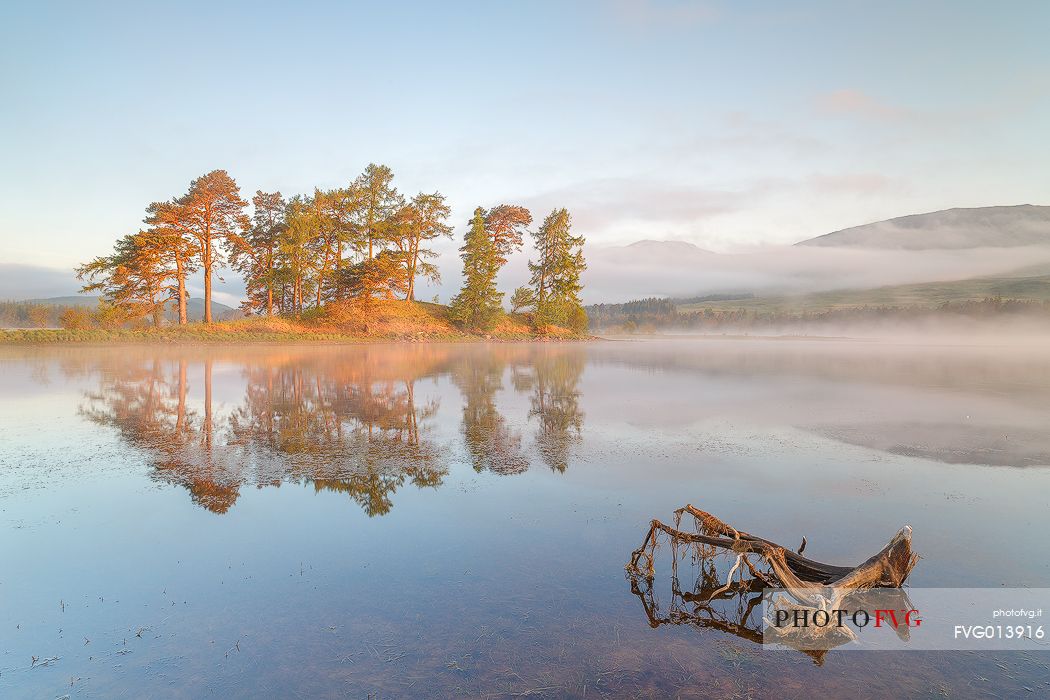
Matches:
[587,297,1050,333]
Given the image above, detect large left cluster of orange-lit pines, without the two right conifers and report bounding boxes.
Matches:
[77,164,452,325]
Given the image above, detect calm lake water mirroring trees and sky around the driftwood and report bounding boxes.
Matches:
[0,340,1050,698]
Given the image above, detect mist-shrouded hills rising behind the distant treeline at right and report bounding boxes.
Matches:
[584,210,1050,303]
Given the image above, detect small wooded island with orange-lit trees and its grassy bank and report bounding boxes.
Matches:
[0,164,588,343]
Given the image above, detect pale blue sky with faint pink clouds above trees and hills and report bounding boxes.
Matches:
[0,0,1050,291]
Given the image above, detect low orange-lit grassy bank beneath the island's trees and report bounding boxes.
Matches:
[0,300,588,344]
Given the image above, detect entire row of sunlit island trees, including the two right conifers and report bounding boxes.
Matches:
[77,164,587,331]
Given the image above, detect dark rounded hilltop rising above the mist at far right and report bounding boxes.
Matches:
[795,205,1050,250]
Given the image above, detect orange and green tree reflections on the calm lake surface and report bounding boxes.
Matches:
[80,345,584,516]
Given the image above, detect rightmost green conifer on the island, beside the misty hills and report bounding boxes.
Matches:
[528,209,587,331]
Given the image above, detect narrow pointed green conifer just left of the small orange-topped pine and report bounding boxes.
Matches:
[448,207,503,331]
